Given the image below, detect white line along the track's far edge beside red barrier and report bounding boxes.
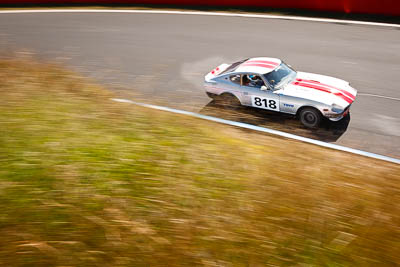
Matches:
[0,9,400,28]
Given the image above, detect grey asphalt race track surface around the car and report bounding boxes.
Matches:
[0,13,400,158]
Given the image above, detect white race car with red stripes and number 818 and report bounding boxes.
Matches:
[204,57,357,128]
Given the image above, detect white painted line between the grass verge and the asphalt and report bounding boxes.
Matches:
[111,98,400,164]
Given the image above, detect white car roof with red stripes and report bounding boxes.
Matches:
[235,57,282,74]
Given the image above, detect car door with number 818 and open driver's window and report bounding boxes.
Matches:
[242,74,280,111]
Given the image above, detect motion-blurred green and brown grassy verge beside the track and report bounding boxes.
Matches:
[0,60,400,266]
